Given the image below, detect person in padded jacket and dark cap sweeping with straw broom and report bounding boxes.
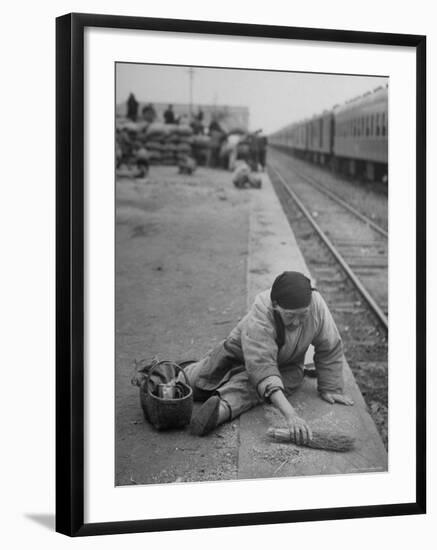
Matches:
[185,271,353,443]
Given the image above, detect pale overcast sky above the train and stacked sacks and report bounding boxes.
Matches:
[116,63,388,133]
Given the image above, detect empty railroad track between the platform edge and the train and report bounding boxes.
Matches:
[269,159,388,334]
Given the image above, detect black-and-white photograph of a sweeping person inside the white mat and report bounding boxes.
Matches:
[115,61,390,486]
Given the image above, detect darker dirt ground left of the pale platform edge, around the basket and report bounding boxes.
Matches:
[115,166,249,485]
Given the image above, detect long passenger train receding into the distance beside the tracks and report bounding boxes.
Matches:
[269,87,388,181]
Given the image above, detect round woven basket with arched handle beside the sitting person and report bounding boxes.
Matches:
[140,361,193,430]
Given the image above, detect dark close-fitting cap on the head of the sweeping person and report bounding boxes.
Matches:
[270,271,312,309]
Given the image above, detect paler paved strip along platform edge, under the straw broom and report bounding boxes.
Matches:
[238,171,387,479]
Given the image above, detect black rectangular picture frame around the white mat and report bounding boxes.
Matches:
[56,14,426,536]
